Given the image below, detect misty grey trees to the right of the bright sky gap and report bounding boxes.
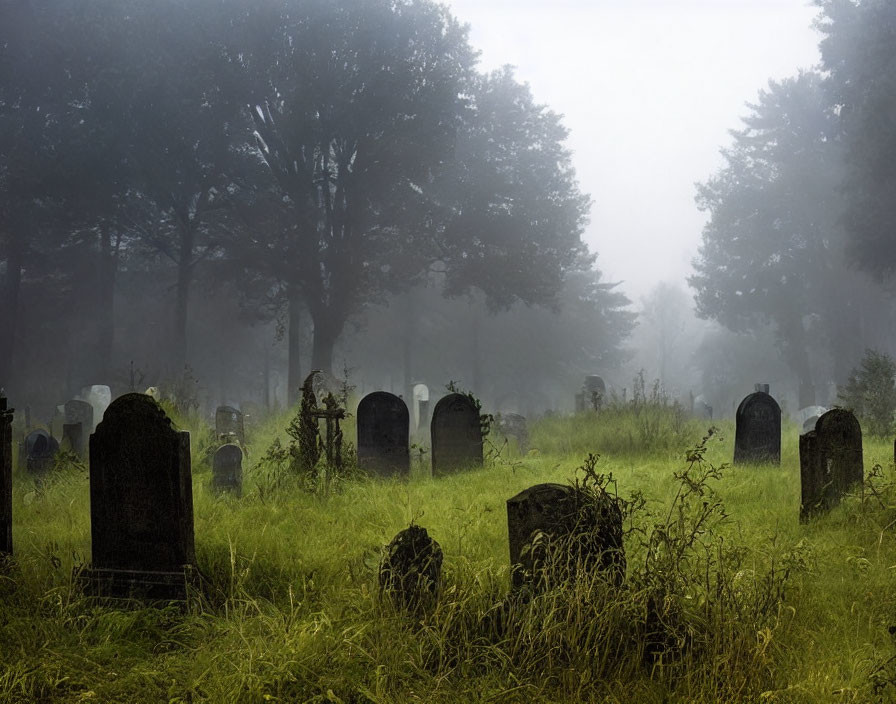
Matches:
[690,0,896,406]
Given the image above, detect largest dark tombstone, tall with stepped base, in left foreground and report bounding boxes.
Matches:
[84,393,196,600]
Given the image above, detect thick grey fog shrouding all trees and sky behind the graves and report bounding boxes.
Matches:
[0,0,896,421]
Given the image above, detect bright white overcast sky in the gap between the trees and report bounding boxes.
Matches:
[446,0,819,302]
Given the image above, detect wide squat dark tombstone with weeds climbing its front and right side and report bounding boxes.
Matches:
[507,484,625,591]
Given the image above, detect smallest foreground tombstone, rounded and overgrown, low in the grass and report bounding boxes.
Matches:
[379,525,442,612]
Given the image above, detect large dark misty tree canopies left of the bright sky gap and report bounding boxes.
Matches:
[0,0,632,412]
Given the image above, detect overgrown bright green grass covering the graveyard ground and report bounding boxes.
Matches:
[0,407,896,703]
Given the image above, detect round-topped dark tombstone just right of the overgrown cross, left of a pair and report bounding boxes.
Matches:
[357,391,411,477]
